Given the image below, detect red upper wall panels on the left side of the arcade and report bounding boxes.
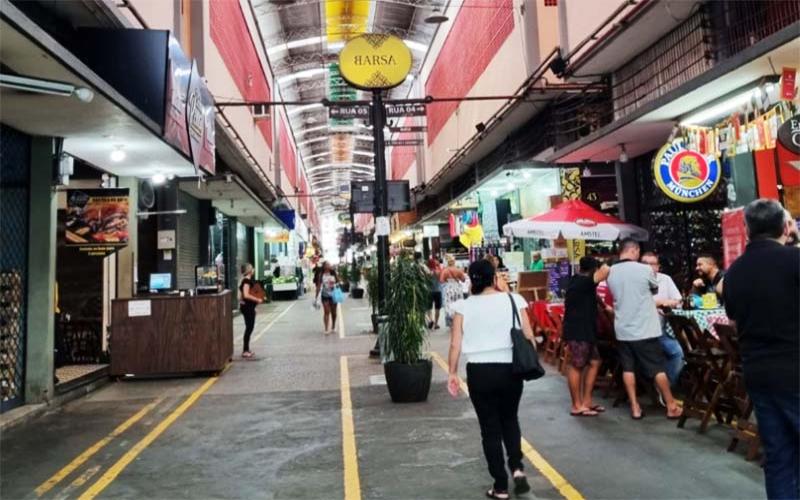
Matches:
[209,0,272,147]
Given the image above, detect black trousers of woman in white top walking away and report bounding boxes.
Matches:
[467,363,523,491]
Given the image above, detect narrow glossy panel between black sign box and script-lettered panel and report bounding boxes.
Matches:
[164,37,192,156]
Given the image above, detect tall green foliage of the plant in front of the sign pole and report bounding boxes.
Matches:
[380,255,431,364]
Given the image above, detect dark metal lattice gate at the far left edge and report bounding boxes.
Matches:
[0,125,31,413]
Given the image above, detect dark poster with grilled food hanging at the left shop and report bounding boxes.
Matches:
[64,188,130,257]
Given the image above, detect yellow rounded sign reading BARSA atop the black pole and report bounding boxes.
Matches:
[339,33,411,90]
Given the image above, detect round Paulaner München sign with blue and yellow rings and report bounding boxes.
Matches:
[653,139,722,203]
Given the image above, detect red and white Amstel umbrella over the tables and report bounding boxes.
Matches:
[503,200,647,241]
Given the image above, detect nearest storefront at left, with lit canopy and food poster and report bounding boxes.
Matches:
[0,4,220,411]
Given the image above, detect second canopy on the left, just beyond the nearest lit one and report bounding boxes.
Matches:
[179,175,286,229]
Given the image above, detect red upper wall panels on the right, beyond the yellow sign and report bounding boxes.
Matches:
[425,0,514,144]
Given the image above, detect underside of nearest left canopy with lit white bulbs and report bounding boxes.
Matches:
[0,3,195,177]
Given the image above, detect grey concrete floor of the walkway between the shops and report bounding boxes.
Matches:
[0,299,765,499]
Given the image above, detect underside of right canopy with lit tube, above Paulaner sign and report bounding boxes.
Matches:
[546,29,800,163]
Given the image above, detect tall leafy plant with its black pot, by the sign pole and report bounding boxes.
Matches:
[378,255,432,403]
